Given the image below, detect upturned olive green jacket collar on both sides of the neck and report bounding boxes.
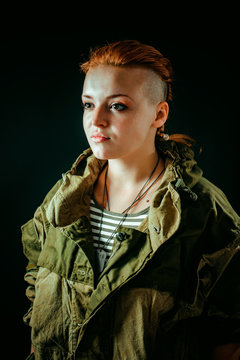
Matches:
[46,139,202,248]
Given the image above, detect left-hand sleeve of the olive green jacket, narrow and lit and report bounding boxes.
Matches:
[21,179,62,324]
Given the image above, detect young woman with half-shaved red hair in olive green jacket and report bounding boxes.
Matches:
[22,41,240,360]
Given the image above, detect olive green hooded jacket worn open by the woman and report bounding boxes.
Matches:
[22,140,240,360]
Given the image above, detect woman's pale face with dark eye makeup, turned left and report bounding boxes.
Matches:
[82,65,166,159]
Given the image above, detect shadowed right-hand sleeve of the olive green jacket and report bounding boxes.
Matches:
[198,186,240,345]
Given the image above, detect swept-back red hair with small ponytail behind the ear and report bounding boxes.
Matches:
[80,40,199,150]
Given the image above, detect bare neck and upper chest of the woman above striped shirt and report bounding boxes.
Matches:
[94,148,165,213]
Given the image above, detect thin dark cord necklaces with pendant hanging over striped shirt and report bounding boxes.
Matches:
[97,155,165,273]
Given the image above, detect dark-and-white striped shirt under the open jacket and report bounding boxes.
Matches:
[90,197,149,260]
